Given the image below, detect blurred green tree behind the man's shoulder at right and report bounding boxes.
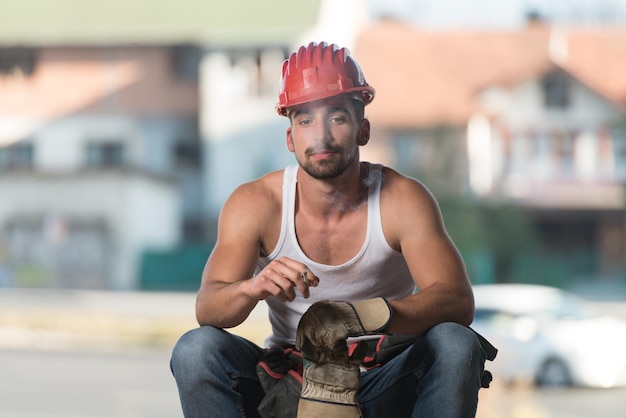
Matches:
[399,126,539,282]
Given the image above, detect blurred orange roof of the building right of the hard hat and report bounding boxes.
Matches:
[353,21,626,128]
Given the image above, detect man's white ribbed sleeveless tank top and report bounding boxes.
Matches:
[257,164,415,347]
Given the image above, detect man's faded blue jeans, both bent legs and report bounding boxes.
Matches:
[170,322,485,418]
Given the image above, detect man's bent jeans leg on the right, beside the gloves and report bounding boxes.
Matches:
[359,322,485,418]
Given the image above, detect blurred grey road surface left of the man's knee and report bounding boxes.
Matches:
[0,350,182,418]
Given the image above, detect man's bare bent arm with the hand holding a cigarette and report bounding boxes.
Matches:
[196,180,317,328]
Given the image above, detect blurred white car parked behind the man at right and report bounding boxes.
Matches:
[472,284,626,388]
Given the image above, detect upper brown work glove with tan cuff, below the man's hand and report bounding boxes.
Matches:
[296,298,392,363]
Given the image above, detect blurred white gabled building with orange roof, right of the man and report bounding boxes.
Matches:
[355,20,626,279]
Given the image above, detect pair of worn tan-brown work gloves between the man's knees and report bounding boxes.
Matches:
[296,298,392,418]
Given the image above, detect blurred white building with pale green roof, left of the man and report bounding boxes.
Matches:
[0,0,320,289]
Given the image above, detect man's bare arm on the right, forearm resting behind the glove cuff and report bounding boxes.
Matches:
[381,169,474,334]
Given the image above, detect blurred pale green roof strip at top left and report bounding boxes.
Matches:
[0,0,320,46]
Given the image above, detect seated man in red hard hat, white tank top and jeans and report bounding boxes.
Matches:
[171,42,485,418]
